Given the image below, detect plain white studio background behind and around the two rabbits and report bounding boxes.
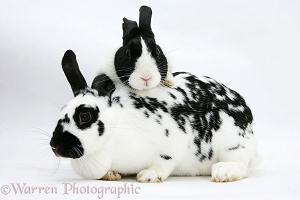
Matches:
[0,0,300,199]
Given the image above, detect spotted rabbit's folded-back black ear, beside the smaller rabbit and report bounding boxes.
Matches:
[92,74,116,96]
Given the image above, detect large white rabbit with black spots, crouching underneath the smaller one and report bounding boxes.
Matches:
[50,50,256,182]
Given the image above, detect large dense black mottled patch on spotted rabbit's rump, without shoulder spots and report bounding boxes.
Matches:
[171,72,253,162]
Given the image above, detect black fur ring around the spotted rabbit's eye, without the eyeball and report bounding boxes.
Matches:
[73,104,99,130]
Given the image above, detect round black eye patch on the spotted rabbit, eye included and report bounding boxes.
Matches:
[73,105,99,130]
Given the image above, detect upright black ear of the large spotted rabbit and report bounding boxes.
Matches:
[61,50,87,96]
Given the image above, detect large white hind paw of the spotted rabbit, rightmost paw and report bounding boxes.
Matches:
[211,162,247,182]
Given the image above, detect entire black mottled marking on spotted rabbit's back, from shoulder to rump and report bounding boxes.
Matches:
[130,72,253,162]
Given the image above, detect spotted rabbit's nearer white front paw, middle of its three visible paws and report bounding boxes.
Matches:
[136,169,167,183]
